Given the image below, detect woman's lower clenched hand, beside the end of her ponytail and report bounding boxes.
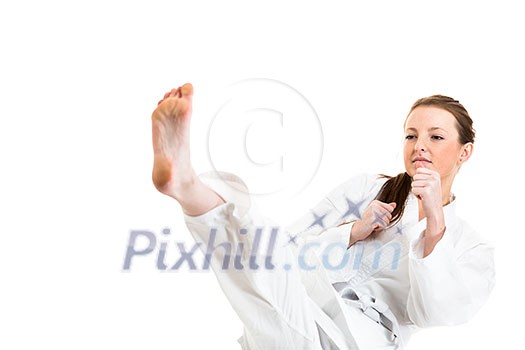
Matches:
[349,200,396,245]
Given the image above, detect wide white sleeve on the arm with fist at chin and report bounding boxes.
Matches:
[407,223,495,327]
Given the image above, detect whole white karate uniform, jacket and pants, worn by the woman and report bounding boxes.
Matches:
[185,173,494,350]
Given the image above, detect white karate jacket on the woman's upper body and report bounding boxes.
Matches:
[287,175,495,347]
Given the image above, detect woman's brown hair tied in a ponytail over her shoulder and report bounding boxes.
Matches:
[376,95,476,224]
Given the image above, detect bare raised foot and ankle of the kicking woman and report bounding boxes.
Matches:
[151,84,224,215]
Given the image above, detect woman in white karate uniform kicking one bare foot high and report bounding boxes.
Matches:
[152,84,494,349]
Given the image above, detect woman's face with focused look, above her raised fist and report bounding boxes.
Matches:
[404,106,472,185]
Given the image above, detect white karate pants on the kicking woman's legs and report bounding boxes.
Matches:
[185,173,396,350]
